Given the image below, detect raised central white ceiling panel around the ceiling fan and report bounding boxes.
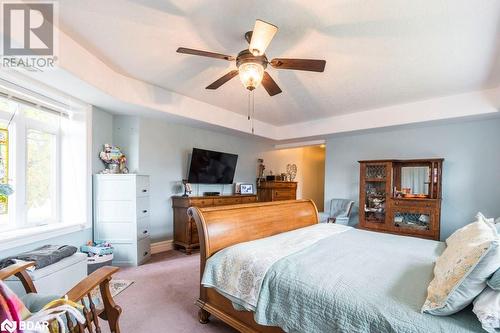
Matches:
[59,0,500,126]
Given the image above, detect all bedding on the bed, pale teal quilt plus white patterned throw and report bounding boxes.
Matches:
[202,224,482,333]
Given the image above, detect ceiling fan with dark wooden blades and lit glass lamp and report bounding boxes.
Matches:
[177,20,326,96]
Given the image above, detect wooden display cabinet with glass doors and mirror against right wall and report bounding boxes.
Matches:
[359,159,444,240]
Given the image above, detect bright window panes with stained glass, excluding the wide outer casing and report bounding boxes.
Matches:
[0,93,65,230]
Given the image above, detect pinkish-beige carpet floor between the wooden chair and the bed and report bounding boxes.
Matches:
[105,251,235,333]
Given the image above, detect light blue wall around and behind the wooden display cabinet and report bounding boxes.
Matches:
[325,118,500,239]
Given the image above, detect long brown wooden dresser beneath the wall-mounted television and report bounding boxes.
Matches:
[172,194,257,254]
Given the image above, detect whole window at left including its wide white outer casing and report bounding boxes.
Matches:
[0,77,92,251]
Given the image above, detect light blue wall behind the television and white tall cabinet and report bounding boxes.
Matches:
[92,109,273,242]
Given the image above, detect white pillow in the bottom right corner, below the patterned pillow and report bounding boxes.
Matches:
[472,287,500,333]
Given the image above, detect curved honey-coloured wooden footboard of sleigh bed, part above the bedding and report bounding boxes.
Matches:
[188,200,318,258]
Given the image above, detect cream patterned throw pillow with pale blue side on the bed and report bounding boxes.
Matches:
[422,213,500,316]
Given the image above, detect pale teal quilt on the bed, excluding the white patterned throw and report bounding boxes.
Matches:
[203,229,482,333]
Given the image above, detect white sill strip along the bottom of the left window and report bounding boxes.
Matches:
[0,224,90,251]
